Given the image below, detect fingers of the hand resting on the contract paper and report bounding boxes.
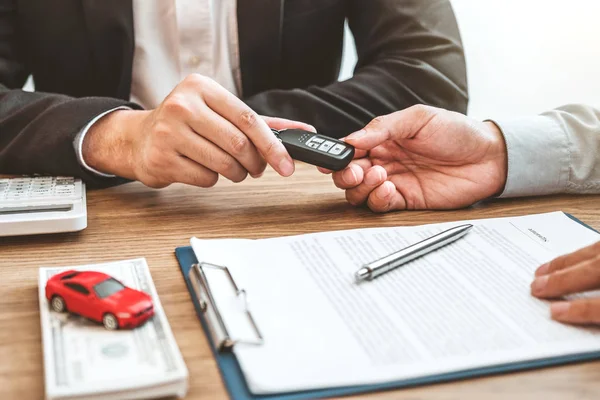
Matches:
[531,242,600,324]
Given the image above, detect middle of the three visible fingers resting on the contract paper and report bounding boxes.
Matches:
[531,257,600,298]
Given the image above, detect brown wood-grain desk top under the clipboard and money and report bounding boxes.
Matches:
[0,166,600,400]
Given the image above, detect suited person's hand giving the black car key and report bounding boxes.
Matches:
[82,74,311,188]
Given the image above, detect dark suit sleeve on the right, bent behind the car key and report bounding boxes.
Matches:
[246,0,468,137]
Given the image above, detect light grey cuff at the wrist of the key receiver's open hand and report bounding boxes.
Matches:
[491,115,570,197]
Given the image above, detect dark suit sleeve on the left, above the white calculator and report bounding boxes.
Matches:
[0,0,137,186]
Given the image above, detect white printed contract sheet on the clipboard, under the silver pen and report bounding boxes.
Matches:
[191,212,600,394]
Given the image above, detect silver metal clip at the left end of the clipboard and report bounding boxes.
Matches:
[189,263,264,351]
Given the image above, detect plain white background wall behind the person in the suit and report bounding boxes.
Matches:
[27,0,600,118]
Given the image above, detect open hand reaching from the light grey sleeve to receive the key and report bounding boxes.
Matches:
[321,106,507,212]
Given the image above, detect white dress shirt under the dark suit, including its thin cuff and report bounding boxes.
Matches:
[74,0,242,177]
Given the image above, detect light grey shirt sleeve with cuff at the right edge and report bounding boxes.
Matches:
[494,104,600,197]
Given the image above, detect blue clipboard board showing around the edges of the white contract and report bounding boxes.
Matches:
[175,214,600,400]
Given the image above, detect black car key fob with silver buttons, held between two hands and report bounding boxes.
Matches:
[271,129,354,171]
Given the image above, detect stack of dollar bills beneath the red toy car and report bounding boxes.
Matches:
[39,258,188,399]
